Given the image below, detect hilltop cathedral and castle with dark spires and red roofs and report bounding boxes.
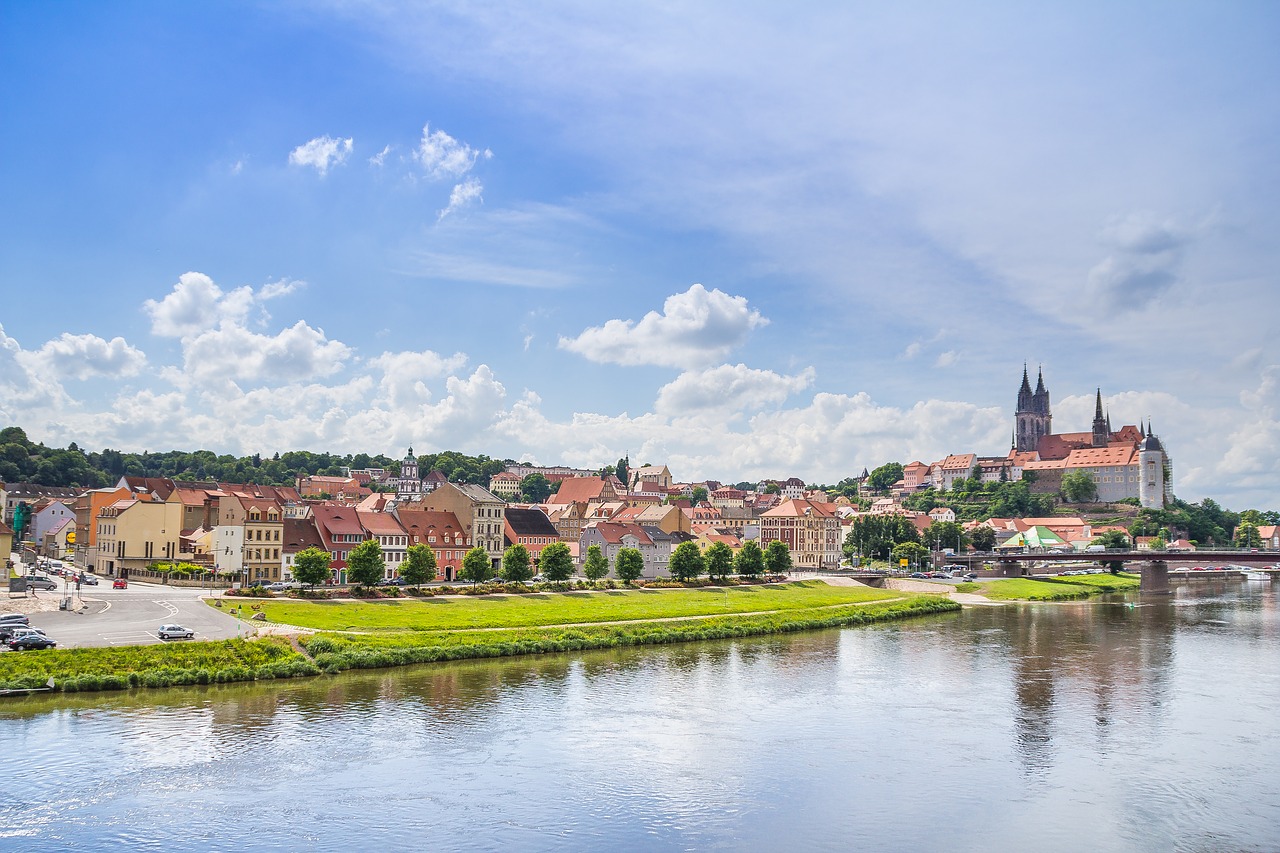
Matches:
[1009,366,1172,508]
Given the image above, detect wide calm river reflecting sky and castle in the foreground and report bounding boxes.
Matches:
[0,581,1280,853]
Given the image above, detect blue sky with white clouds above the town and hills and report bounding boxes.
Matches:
[0,3,1280,508]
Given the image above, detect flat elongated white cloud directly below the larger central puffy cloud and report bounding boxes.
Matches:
[654,364,814,416]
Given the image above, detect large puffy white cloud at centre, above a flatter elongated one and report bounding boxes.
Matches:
[559,284,768,368]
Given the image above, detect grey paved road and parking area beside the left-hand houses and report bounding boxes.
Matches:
[9,580,252,648]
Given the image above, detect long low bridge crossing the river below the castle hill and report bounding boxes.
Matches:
[947,549,1280,593]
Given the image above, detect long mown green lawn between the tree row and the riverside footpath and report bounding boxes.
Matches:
[227,580,904,631]
